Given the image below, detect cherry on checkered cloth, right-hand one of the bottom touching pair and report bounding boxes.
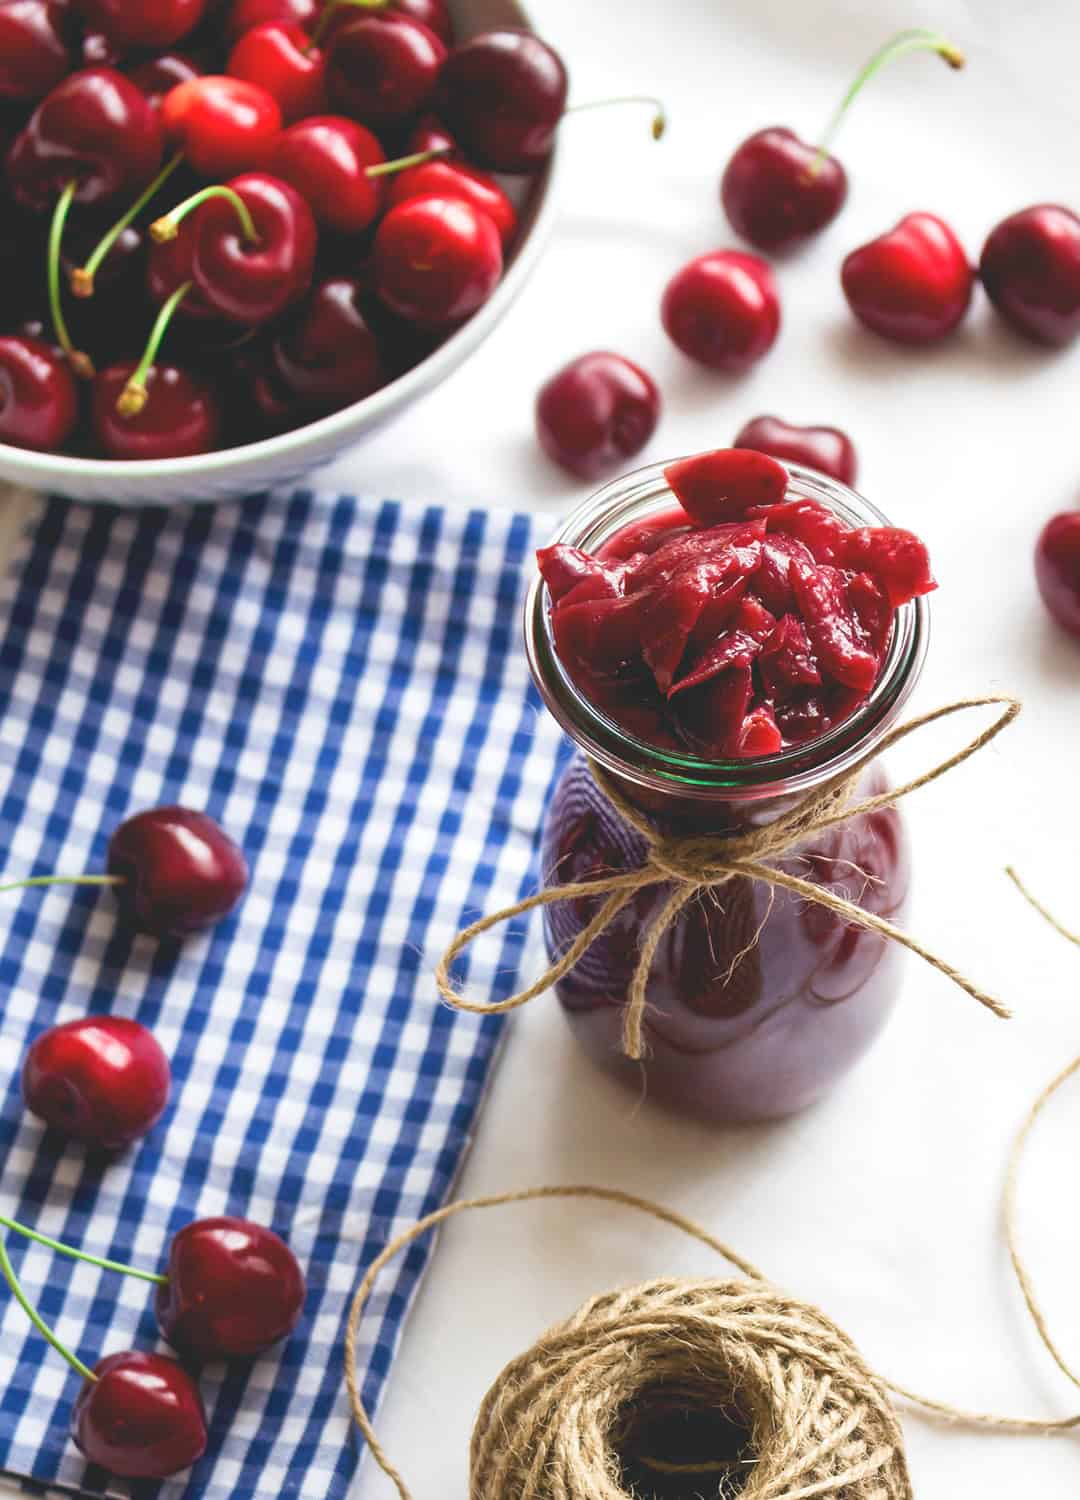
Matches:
[156,1218,308,1361]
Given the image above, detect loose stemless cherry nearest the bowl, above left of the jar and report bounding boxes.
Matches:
[536,351,660,479]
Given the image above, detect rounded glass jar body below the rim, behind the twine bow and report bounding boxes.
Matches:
[543,755,911,1122]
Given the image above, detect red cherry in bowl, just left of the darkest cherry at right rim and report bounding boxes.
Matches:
[327,12,447,126]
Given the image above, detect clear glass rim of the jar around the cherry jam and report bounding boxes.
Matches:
[525,459,930,800]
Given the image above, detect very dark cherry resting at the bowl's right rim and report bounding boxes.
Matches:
[438,29,569,173]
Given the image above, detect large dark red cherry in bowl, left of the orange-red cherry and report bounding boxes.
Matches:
[8,68,162,213]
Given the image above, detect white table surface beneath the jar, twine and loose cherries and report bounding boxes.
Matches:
[5,0,1080,1500]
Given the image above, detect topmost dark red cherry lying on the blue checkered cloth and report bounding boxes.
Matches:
[108,807,248,938]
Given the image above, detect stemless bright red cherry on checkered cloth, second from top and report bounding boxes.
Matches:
[23,1016,173,1151]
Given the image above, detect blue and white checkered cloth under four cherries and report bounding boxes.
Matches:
[0,494,560,1500]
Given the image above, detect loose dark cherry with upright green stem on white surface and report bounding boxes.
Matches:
[720,126,848,251]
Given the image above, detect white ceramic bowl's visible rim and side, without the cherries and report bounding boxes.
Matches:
[0,0,558,506]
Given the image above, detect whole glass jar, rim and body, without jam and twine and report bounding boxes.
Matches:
[525,465,929,1122]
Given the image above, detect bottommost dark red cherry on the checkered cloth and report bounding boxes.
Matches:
[72,1352,207,1479]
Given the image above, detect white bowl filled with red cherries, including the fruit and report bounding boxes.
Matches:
[0,0,567,503]
